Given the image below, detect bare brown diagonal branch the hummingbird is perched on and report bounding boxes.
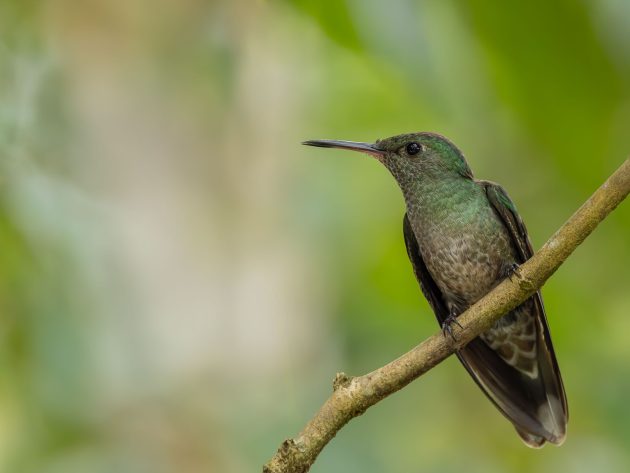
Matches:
[263,159,630,473]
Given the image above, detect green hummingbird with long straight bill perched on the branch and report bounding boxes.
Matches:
[303,132,568,448]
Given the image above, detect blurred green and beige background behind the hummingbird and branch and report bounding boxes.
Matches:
[0,0,630,473]
